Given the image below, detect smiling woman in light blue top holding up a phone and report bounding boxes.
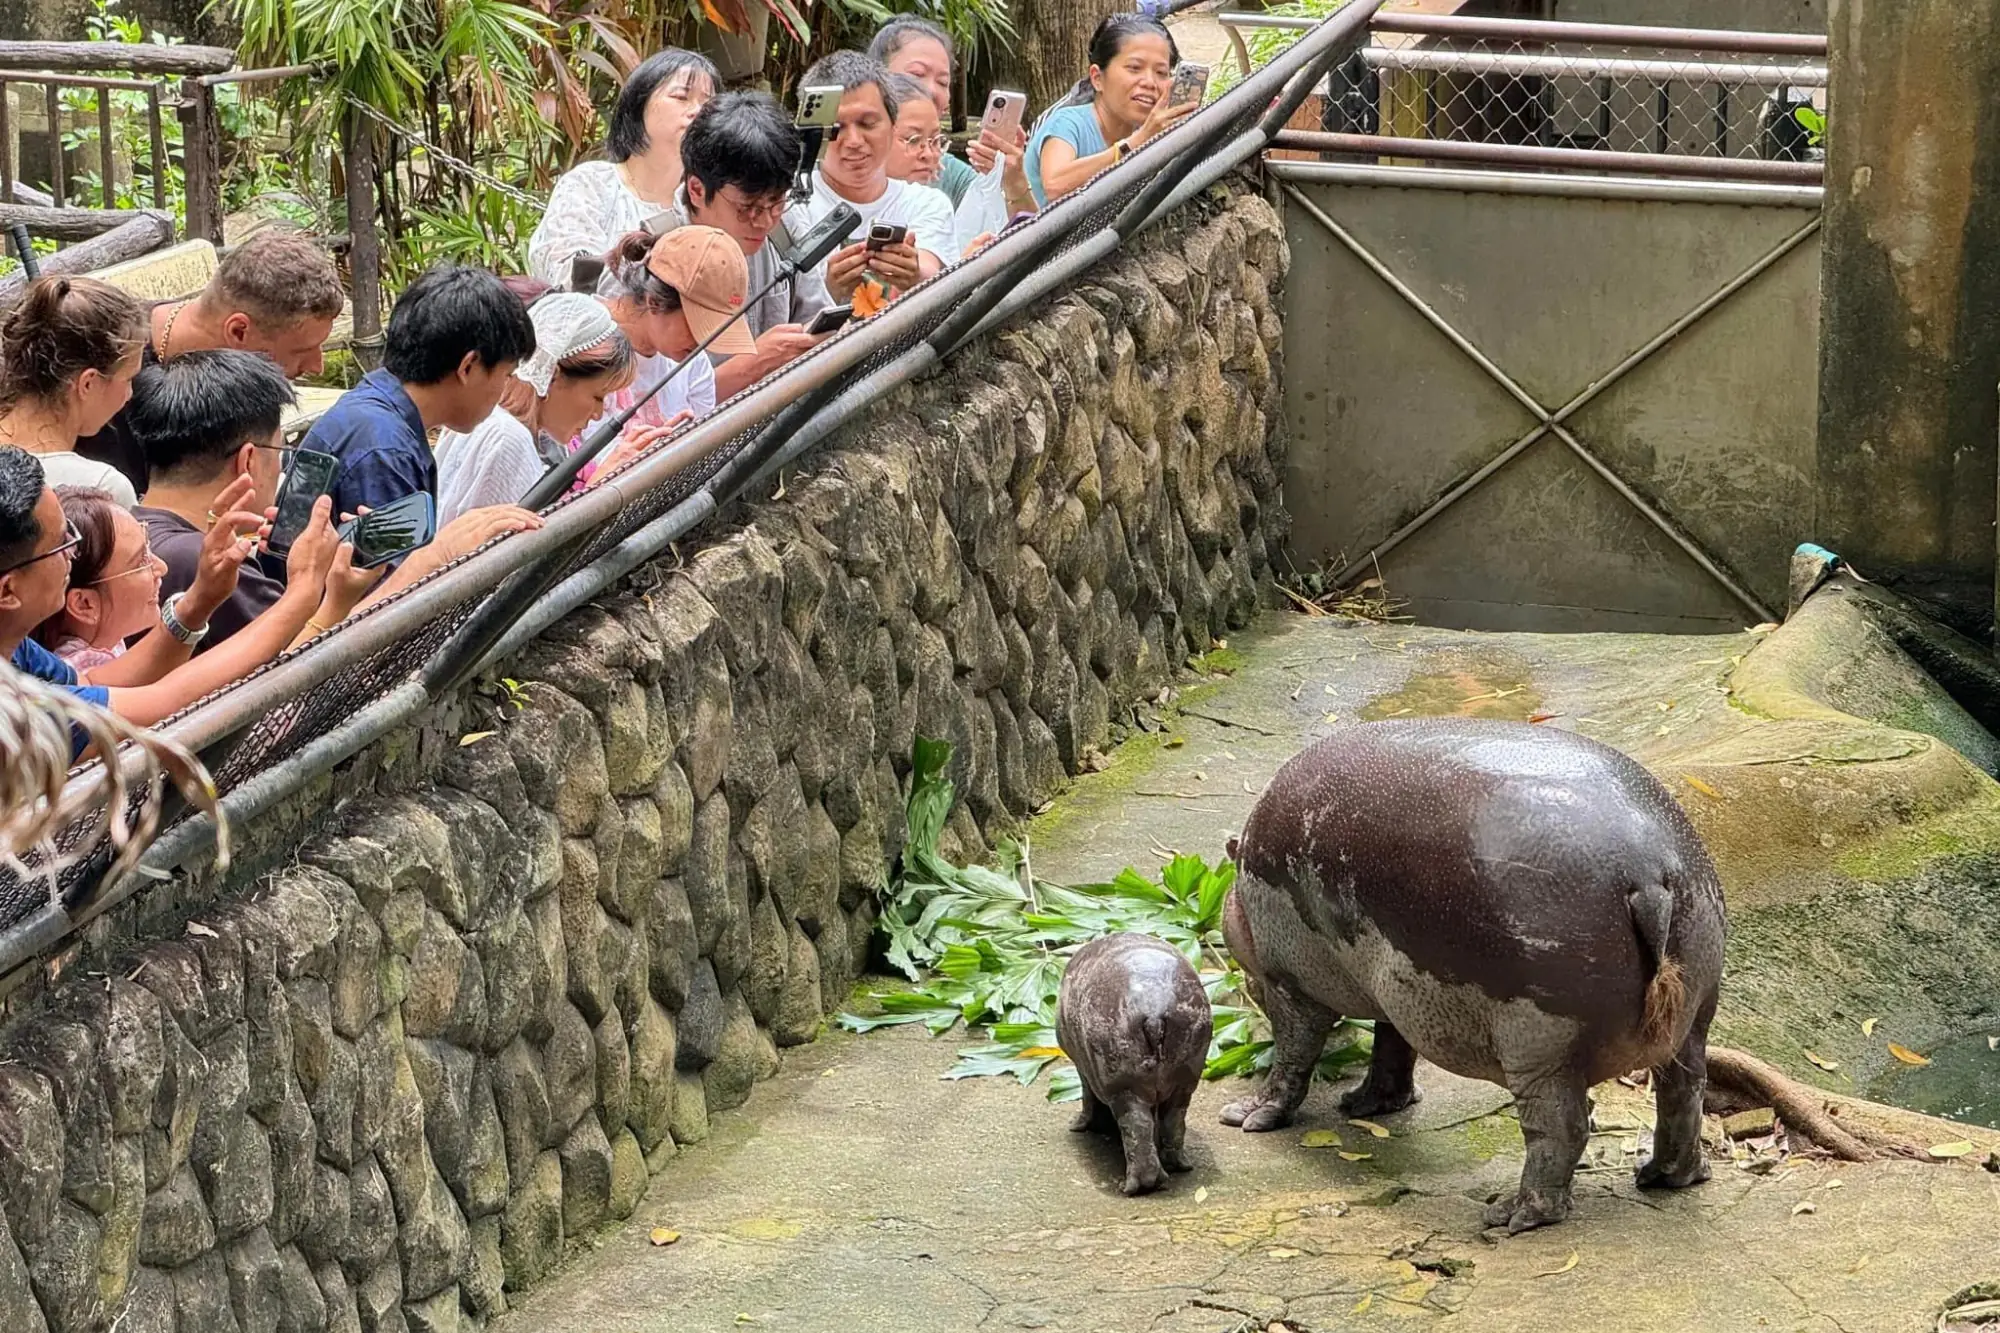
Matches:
[1028,14,1200,208]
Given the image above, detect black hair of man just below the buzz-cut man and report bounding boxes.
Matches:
[128,348,294,482]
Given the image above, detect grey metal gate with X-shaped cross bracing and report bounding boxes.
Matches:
[1268,162,1820,632]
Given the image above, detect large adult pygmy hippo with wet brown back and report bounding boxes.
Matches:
[1222,719,1726,1231]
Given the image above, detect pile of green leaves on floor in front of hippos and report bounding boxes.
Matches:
[838,737,1368,1101]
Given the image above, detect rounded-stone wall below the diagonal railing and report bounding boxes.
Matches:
[0,192,1284,1333]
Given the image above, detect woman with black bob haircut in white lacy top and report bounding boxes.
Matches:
[528,46,720,288]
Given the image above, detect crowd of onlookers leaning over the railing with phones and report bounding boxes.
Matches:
[0,14,1194,755]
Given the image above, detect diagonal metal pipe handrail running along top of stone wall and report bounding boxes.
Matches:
[0,0,1382,973]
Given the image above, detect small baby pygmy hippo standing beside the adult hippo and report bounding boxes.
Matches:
[1056,935,1212,1195]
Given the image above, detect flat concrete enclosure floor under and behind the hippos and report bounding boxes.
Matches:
[496,616,2000,1333]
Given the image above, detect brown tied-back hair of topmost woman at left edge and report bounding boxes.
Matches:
[0,276,146,408]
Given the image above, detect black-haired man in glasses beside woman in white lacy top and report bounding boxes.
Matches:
[674,92,834,400]
